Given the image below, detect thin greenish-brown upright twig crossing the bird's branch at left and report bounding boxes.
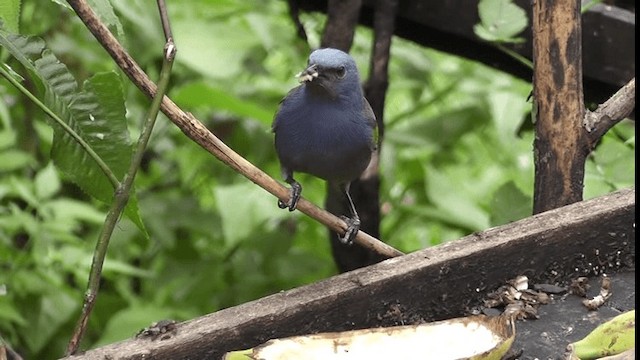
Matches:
[67,4,177,355]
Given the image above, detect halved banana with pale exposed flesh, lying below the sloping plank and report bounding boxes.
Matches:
[224,315,515,360]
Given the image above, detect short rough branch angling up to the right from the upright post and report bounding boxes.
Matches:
[583,78,636,146]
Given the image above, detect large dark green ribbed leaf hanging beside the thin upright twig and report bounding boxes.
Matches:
[0,30,146,234]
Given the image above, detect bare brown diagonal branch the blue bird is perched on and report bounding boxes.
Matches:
[68,0,403,257]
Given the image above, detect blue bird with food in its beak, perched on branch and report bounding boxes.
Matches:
[272,48,377,245]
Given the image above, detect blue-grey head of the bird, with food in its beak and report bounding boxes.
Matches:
[297,48,361,98]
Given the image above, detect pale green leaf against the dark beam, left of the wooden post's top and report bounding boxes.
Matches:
[473,0,528,43]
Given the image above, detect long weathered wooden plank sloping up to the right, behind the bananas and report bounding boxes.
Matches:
[65,189,635,359]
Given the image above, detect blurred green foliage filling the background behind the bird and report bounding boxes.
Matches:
[0,0,635,359]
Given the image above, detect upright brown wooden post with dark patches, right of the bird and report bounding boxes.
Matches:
[533,0,590,214]
